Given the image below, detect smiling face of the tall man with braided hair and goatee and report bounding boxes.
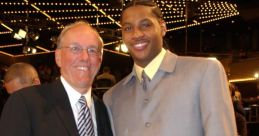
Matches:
[121,5,166,67]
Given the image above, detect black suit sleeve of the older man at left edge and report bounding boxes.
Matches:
[0,93,31,136]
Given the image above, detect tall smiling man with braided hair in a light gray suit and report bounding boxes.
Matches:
[103,0,237,136]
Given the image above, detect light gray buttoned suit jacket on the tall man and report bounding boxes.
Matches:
[103,51,237,136]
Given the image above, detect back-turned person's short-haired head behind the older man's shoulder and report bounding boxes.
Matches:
[4,62,40,94]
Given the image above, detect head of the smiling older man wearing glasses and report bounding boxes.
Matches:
[55,25,102,93]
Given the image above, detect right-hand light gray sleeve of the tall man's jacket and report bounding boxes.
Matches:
[200,60,237,136]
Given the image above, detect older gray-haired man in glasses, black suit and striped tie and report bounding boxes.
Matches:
[0,21,113,136]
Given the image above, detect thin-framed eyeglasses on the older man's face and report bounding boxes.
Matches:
[59,46,102,56]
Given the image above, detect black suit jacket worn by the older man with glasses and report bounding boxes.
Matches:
[0,80,112,136]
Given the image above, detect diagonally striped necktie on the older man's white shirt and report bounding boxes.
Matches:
[77,96,94,136]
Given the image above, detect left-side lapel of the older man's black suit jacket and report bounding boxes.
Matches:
[51,80,79,136]
